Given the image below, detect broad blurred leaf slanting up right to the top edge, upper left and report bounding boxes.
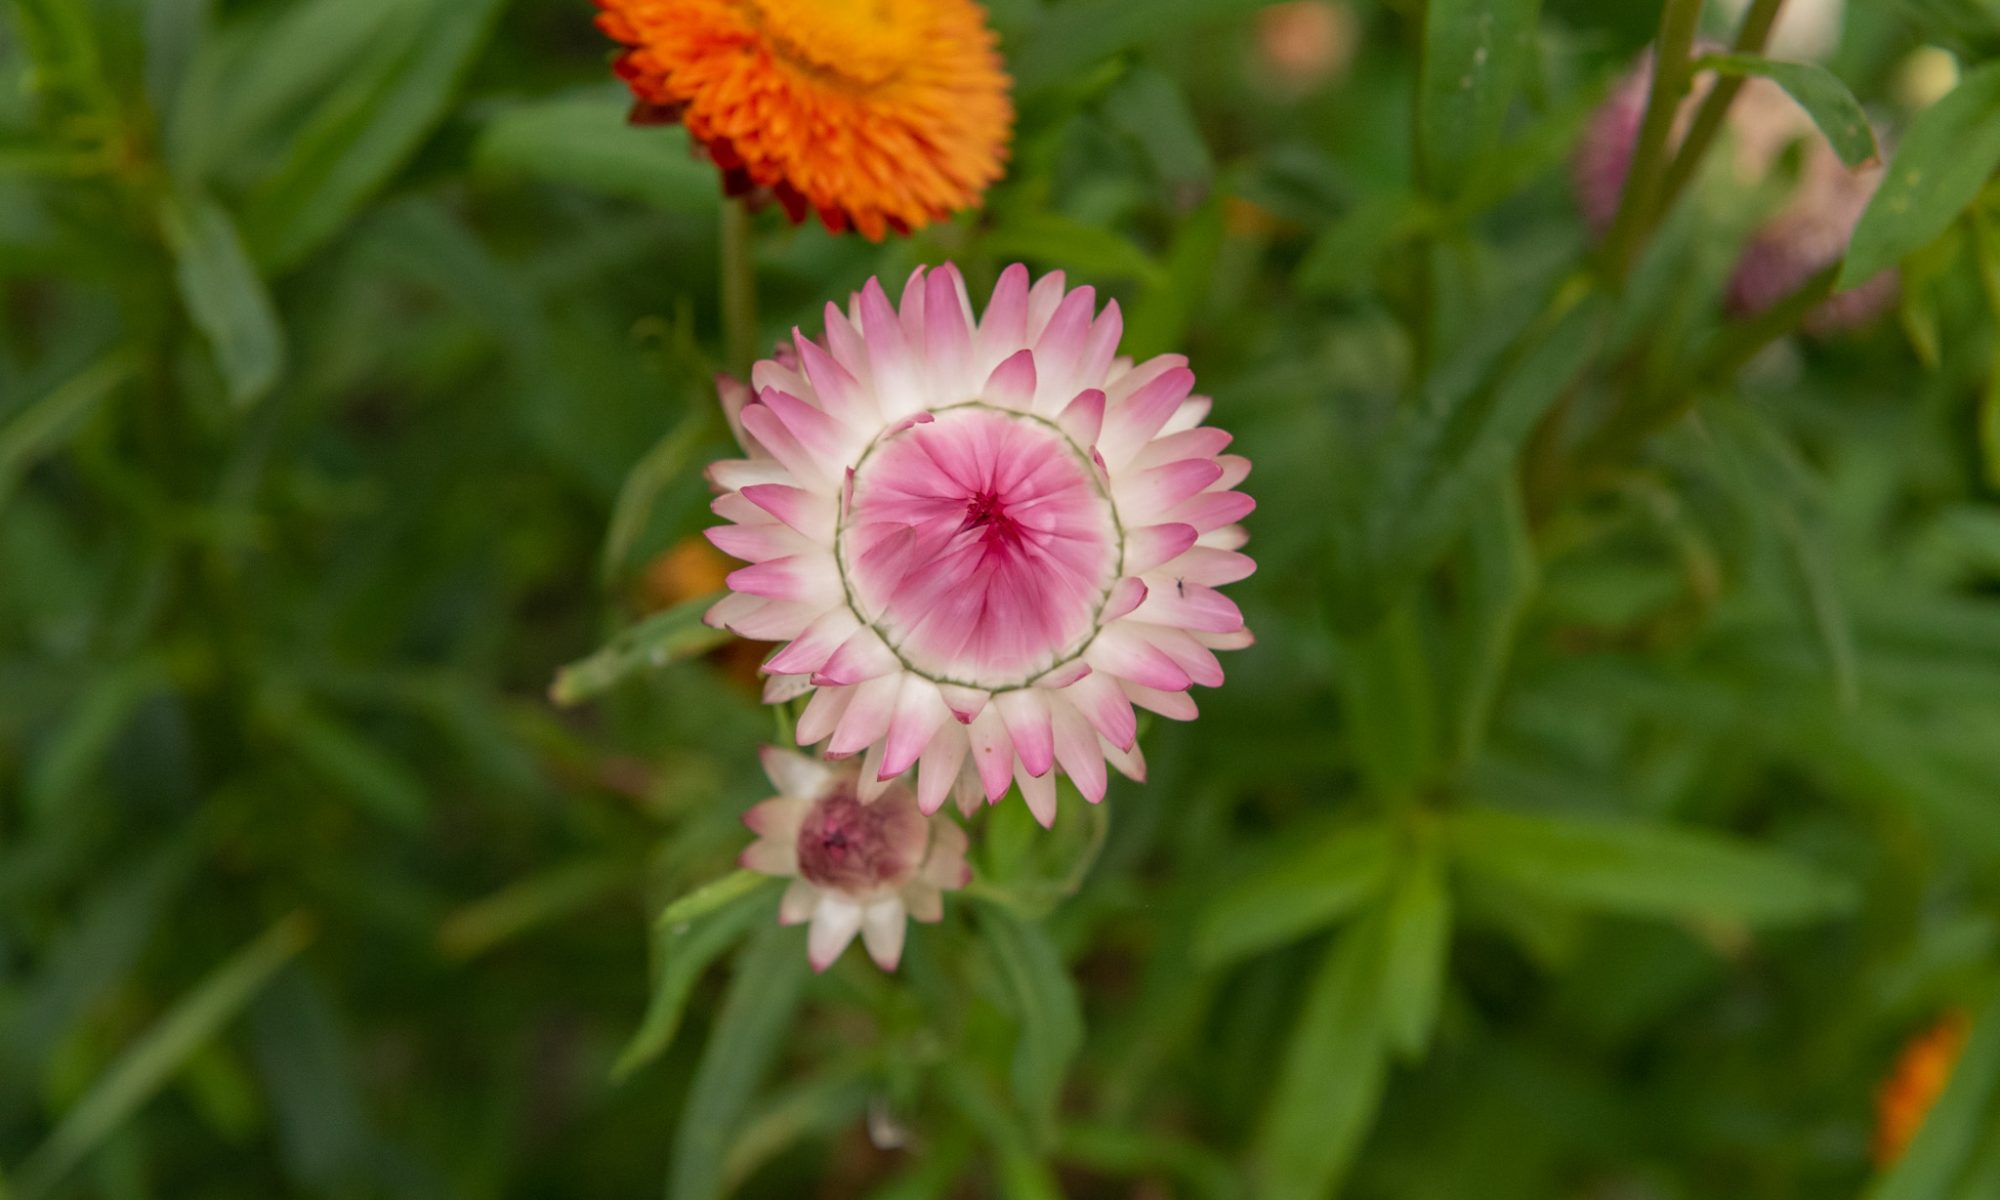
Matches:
[240,0,500,270]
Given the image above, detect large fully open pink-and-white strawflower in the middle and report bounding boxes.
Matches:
[708,266,1254,824]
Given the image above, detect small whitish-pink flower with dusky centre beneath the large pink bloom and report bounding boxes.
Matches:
[738,746,972,970]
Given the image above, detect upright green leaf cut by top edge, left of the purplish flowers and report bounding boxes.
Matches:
[1416,0,1542,196]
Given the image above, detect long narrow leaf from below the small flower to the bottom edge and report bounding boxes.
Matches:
[666,928,806,1200]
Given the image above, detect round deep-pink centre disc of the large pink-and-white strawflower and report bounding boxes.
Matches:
[834,404,1124,690]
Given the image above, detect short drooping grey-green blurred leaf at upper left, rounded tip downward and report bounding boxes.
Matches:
[160,196,284,408]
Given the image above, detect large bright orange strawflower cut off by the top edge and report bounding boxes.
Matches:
[596,0,1014,240]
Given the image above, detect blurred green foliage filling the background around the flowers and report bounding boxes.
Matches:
[0,0,2000,1200]
